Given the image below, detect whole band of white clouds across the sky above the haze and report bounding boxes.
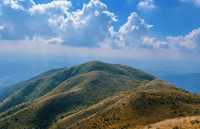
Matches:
[0,0,200,52]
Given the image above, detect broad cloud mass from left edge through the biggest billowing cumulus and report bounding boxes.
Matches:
[0,0,117,47]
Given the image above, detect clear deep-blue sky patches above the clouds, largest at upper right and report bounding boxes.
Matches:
[32,0,200,36]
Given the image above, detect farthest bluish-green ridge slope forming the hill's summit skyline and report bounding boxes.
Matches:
[0,61,154,112]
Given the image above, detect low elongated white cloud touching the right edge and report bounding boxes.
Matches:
[143,28,200,52]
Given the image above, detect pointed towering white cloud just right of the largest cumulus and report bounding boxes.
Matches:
[116,12,153,47]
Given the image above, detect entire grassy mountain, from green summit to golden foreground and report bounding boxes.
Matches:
[0,61,200,129]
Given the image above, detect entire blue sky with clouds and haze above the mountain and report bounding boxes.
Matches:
[0,0,200,87]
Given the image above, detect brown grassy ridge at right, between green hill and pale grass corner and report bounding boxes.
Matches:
[51,80,200,129]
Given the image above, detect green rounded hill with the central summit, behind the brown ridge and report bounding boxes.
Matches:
[0,62,154,129]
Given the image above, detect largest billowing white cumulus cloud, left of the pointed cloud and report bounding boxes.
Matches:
[49,0,117,47]
